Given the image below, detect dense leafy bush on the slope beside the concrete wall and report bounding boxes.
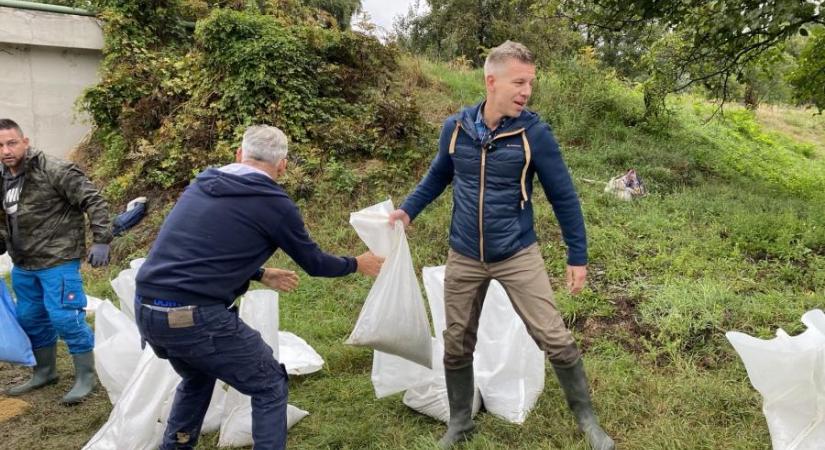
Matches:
[76,0,431,198]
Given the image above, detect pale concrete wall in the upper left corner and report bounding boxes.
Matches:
[0,7,103,157]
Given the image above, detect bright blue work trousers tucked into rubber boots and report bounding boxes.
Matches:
[11,260,95,355]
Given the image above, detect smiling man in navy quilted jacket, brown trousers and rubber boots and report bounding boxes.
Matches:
[390,41,614,450]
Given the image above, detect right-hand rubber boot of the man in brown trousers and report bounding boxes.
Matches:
[553,358,616,450]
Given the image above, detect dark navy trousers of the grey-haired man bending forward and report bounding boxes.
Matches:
[135,297,288,450]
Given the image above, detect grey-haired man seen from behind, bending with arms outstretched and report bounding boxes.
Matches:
[135,125,383,450]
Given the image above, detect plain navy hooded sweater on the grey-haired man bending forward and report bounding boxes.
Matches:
[136,169,356,305]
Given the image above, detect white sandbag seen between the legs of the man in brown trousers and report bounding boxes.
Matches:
[473,280,544,423]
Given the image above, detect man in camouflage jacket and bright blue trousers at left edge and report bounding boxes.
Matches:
[0,119,112,404]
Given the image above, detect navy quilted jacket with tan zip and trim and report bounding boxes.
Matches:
[401,103,587,265]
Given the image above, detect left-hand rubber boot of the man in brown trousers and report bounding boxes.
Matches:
[438,364,476,449]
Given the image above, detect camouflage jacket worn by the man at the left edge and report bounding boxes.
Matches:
[0,148,112,270]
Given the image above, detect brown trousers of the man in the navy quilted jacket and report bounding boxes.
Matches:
[444,243,581,370]
